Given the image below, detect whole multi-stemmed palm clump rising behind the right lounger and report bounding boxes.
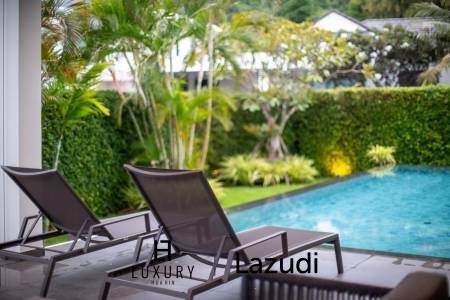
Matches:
[91,0,237,168]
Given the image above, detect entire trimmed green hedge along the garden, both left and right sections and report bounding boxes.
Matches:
[42,86,450,216]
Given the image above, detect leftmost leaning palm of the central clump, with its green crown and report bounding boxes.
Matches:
[91,0,174,161]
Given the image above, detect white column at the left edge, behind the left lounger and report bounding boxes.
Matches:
[0,0,41,241]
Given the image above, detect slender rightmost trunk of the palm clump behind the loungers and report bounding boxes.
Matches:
[199,22,214,169]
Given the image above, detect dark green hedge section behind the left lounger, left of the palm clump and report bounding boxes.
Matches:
[42,92,135,216]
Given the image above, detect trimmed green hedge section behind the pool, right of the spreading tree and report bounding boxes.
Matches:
[286,85,450,173]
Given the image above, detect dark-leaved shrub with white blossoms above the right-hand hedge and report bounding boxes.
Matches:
[332,25,438,87]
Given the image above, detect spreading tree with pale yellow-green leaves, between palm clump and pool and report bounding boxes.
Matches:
[237,13,371,160]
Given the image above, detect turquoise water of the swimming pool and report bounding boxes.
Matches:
[228,166,450,258]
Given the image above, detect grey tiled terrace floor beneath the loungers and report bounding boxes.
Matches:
[0,242,450,300]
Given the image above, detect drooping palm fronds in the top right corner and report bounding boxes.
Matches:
[409,0,450,84]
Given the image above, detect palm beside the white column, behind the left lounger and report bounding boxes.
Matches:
[41,0,109,168]
